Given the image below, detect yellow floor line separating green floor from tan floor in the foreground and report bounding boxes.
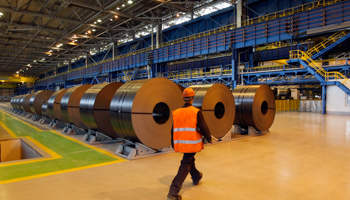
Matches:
[0,160,124,185]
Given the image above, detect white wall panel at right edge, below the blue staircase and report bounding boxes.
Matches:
[326,85,350,115]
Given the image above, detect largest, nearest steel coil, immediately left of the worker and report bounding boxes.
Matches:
[110,78,184,149]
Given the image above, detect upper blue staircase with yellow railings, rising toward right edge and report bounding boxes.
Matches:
[306,31,350,60]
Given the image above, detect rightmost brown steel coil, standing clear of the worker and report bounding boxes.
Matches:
[232,85,276,131]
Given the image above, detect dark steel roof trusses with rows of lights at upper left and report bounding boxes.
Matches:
[0,0,224,75]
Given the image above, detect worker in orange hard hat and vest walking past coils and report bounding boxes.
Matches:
[167,88,212,200]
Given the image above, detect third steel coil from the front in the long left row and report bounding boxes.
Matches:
[61,84,92,129]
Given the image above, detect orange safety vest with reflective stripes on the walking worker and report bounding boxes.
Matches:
[173,106,203,153]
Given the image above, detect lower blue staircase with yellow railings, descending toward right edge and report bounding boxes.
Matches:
[289,49,350,95]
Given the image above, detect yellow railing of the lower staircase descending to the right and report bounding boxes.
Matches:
[289,50,350,86]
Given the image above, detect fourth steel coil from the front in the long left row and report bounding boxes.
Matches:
[46,89,68,121]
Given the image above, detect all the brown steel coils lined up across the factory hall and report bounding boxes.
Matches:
[11,78,275,149]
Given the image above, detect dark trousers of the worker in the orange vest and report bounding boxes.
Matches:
[169,153,200,196]
